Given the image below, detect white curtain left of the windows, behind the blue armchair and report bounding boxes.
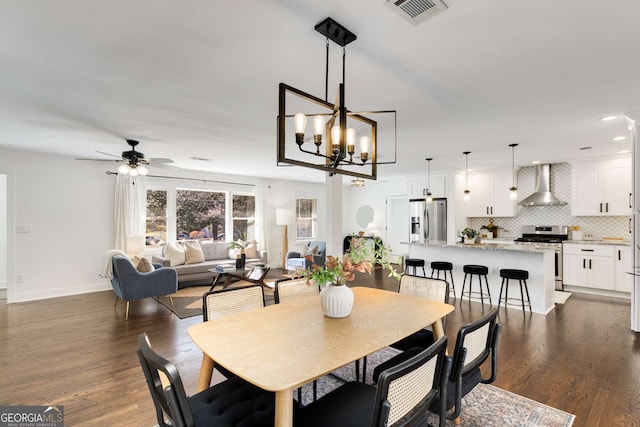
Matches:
[113,175,147,251]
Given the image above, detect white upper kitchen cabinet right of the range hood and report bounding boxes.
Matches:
[571,159,632,216]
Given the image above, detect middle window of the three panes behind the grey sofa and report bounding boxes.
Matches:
[176,189,226,240]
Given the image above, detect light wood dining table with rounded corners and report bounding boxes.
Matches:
[188,287,453,427]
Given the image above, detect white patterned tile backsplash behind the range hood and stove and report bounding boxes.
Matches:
[469,163,631,239]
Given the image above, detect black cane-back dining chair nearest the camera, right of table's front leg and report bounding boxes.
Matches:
[295,337,451,427]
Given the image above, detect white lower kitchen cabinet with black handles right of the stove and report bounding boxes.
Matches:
[562,244,616,290]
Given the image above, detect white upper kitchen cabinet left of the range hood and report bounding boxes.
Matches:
[463,170,516,217]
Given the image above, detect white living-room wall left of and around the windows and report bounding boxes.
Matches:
[0,148,326,303]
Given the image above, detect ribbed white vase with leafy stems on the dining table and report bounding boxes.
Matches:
[303,234,400,318]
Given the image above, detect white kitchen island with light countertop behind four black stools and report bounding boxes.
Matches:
[408,242,555,314]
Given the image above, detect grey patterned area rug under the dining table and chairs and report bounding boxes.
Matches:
[294,347,575,427]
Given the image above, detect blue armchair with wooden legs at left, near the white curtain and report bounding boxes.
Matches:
[111,255,178,320]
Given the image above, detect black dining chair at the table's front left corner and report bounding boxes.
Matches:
[136,333,275,427]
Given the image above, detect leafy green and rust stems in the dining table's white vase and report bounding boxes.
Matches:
[303,234,400,286]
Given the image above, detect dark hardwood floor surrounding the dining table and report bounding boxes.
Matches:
[0,271,640,426]
